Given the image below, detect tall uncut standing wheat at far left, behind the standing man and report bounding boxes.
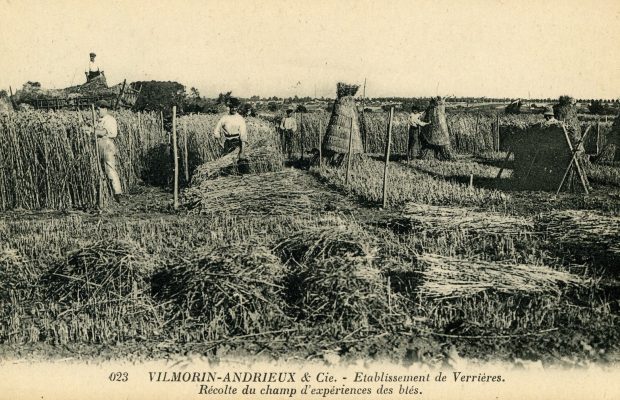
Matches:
[0,111,166,210]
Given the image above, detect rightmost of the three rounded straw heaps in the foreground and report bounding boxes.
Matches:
[276,217,400,336]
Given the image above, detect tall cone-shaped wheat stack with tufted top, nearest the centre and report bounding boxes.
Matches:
[322,83,364,158]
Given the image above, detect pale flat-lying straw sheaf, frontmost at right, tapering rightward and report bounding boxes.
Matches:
[418,254,582,299]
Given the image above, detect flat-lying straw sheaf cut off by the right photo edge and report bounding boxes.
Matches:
[538,210,620,274]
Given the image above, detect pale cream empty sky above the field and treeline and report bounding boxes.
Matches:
[0,0,620,98]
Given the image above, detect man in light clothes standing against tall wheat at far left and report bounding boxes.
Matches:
[95,100,123,202]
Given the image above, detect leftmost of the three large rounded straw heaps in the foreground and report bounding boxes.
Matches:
[43,241,163,343]
